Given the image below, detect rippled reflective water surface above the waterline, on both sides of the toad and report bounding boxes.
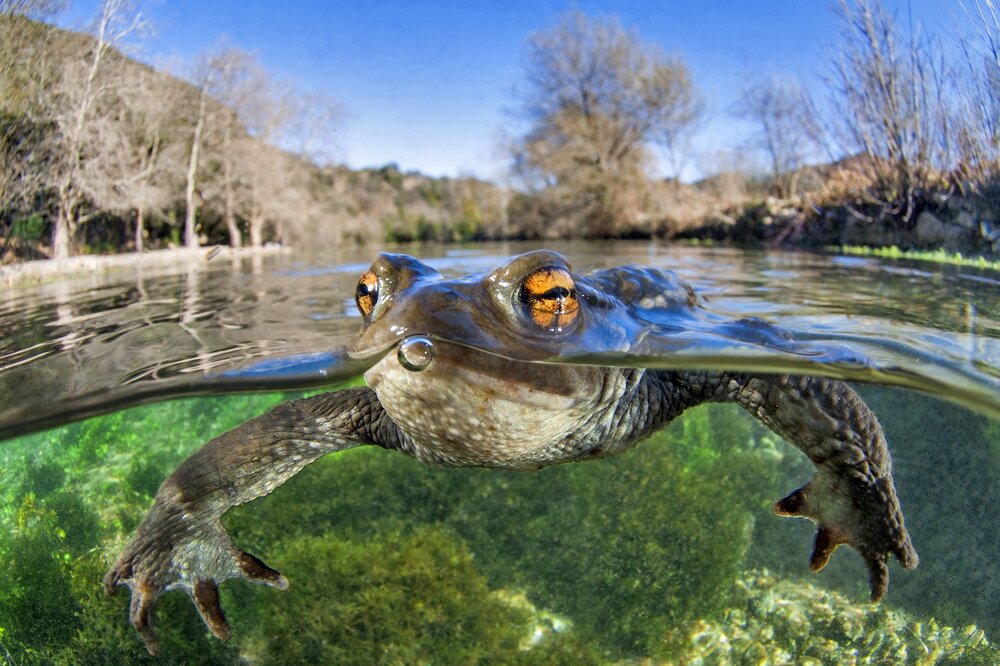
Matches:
[0,242,1000,437]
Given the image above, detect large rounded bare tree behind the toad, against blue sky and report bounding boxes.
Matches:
[513,11,700,235]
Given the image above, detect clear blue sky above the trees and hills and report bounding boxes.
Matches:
[59,0,961,180]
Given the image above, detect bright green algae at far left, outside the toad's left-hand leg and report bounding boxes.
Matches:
[0,395,292,664]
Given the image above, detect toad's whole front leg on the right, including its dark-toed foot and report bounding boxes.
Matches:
[657,372,917,601]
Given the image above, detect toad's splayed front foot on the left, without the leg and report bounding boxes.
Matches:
[104,501,288,655]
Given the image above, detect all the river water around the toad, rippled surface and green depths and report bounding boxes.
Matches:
[0,242,1000,663]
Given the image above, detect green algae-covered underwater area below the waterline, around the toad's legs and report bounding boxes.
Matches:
[0,382,1000,664]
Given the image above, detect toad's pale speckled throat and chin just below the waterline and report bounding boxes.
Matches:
[365,356,593,469]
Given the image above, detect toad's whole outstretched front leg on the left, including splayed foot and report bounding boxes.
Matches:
[104,388,403,654]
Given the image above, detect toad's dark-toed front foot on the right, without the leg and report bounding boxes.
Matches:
[774,473,918,601]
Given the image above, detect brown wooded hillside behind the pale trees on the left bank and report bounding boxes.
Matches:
[0,15,510,261]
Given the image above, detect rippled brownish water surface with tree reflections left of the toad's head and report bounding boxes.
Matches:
[0,250,357,436]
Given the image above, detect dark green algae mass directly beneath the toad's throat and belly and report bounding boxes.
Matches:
[226,396,787,656]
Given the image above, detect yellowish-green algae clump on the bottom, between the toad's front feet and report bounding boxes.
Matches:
[234,527,593,664]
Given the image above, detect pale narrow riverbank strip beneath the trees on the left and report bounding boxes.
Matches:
[0,245,291,286]
